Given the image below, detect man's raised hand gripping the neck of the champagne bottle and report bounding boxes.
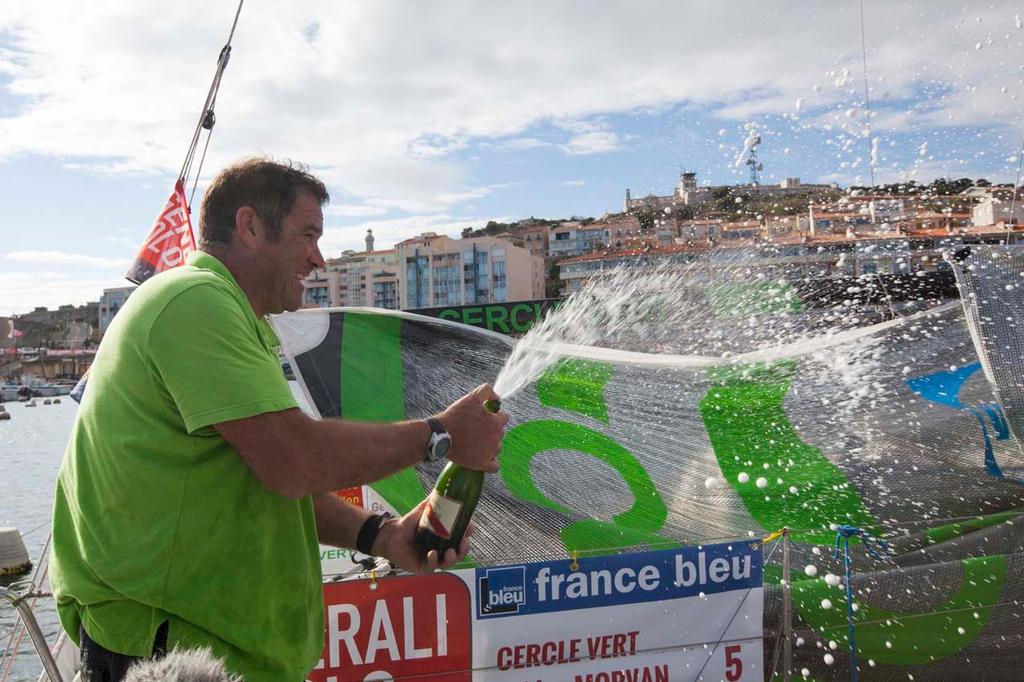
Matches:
[437,384,509,473]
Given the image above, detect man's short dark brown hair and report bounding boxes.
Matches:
[200,157,331,249]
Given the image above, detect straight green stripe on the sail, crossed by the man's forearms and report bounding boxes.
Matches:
[341,312,426,514]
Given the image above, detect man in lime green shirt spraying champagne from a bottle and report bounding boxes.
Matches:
[51,159,508,682]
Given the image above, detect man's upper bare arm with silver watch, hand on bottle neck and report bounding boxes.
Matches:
[214,384,508,497]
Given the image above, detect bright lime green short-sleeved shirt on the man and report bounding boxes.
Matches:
[50,253,324,682]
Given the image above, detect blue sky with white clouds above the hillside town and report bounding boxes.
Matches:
[0,0,1024,315]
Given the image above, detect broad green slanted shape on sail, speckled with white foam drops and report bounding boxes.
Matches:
[699,361,877,543]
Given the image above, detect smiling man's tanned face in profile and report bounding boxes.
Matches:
[260,187,324,314]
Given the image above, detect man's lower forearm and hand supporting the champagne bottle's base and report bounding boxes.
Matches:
[313,493,474,573]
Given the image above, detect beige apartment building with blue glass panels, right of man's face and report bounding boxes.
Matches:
[395,232,544,310]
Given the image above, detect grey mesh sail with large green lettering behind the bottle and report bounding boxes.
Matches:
[274,246,1024,680]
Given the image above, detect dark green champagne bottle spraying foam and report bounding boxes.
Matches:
[416,400,502,559]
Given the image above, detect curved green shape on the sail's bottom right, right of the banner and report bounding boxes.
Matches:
[793,556,1007,666]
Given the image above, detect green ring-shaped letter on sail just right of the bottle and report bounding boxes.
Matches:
[499,419,679,554]
